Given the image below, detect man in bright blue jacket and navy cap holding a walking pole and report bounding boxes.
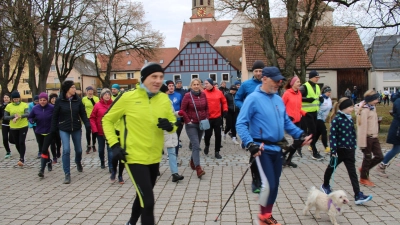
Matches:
[236,67,311,224]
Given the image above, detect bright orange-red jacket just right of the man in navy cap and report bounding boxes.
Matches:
[282,88,307,123]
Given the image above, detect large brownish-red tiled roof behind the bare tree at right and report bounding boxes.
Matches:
[243,21,371,70]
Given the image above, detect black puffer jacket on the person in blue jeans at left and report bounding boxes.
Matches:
[51,94,90,132]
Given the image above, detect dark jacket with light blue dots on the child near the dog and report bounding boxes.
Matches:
[329,112,357,153]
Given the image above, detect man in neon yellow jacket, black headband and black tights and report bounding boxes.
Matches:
[102,63,176,225]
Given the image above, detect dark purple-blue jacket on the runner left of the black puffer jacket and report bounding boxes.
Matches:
[28,103,54,134]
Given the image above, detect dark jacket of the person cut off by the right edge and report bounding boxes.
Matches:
[386,92,400,145]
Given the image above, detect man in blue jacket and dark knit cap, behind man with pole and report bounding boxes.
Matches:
[235,60,265,193]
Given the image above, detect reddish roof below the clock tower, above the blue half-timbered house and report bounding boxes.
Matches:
[179,20,231,49]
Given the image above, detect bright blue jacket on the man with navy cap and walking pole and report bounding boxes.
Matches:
[236,85,303,151]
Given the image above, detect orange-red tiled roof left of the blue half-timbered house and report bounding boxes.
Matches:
[97,48,179,71]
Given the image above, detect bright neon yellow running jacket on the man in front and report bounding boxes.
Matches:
[101,86,176,165]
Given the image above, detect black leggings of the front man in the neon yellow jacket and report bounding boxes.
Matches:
[128,163,160,225]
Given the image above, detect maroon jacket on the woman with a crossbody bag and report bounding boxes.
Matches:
[179,91,209,124]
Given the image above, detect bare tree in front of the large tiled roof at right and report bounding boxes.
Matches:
[217,0,368,81]
